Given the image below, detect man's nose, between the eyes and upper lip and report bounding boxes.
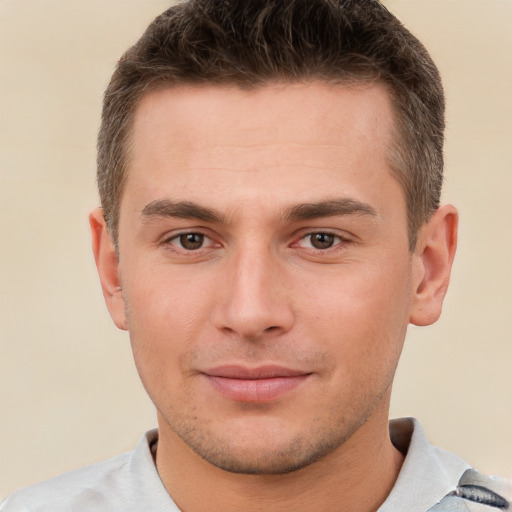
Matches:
[213,247,294,340]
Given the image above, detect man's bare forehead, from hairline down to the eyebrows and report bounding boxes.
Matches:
[125,82,400,217]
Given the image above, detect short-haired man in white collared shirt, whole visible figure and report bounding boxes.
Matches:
[1,0,509,512]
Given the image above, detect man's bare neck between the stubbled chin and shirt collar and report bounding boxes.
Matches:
[157,398,403,512]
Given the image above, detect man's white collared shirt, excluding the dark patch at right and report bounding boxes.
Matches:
[0,418,487,512]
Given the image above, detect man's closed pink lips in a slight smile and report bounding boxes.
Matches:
[202,366,312,403]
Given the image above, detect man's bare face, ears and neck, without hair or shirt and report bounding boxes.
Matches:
[90,82,457,512]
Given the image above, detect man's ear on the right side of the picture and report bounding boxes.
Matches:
[410,205,458,325]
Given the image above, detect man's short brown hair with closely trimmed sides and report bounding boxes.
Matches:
[98,0,444,250]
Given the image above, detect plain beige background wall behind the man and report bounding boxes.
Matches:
[0,0,512,496]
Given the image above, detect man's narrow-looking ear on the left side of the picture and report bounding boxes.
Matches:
[89,208,127,331]
